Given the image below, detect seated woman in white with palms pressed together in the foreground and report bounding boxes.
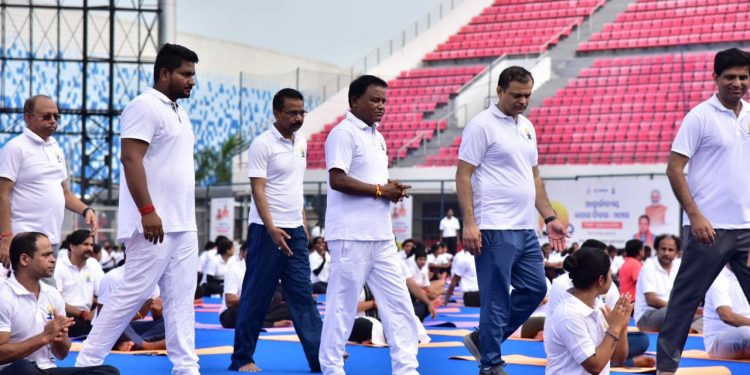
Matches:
[544,248,633,375]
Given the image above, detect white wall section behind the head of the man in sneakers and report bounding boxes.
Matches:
[454,56,552,128]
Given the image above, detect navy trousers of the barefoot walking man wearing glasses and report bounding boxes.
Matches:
[229,224,323,372]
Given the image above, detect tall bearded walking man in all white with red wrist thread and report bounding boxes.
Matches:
[76,43,199,374]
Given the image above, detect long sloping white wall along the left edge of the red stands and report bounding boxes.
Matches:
[298,0,494,139]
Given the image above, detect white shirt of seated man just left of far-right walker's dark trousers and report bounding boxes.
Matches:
[633,258,682,323]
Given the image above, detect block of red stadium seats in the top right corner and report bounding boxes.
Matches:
[578,0,750,52]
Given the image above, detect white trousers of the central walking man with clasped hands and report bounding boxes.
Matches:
[319,240,419,375]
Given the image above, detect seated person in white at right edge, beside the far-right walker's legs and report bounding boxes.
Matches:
[703,265,750,359]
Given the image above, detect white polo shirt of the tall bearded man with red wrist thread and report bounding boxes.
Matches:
[117,88,198,239]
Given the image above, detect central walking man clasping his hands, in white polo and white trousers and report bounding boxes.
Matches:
[320,75,419,375]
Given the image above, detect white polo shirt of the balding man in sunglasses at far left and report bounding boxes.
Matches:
[0,128,68,244]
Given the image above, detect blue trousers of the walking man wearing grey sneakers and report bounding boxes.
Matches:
[474,230,547,368]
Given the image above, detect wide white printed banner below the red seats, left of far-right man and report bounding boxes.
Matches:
[538,176,680,247]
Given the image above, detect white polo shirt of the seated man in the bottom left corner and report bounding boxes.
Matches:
[0,276,65,371]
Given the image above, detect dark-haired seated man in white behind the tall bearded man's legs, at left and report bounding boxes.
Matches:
[55,229,104,337]
